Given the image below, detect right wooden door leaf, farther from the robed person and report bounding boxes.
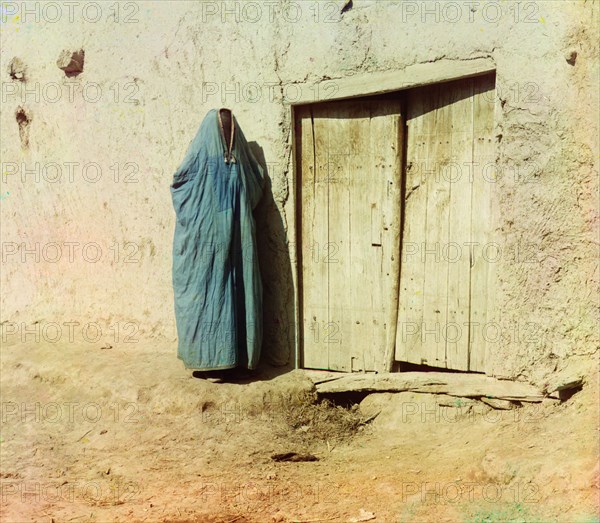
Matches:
[395,76,496,371]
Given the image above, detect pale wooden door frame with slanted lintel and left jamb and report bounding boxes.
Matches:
[284,57,496,372]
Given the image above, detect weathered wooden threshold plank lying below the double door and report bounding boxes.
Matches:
[316,372,546,403]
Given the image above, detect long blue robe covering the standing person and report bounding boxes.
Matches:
[171,109,264,370]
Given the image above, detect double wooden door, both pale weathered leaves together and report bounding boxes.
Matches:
[296,76,498,372]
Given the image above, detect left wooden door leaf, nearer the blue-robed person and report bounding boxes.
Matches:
[295,99,403,372]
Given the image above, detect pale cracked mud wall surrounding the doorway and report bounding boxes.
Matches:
[0,0,598,381]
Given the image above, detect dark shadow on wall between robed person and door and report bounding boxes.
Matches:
[248,142,296,370]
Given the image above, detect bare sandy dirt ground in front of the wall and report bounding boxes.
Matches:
[0,343,599,523]
